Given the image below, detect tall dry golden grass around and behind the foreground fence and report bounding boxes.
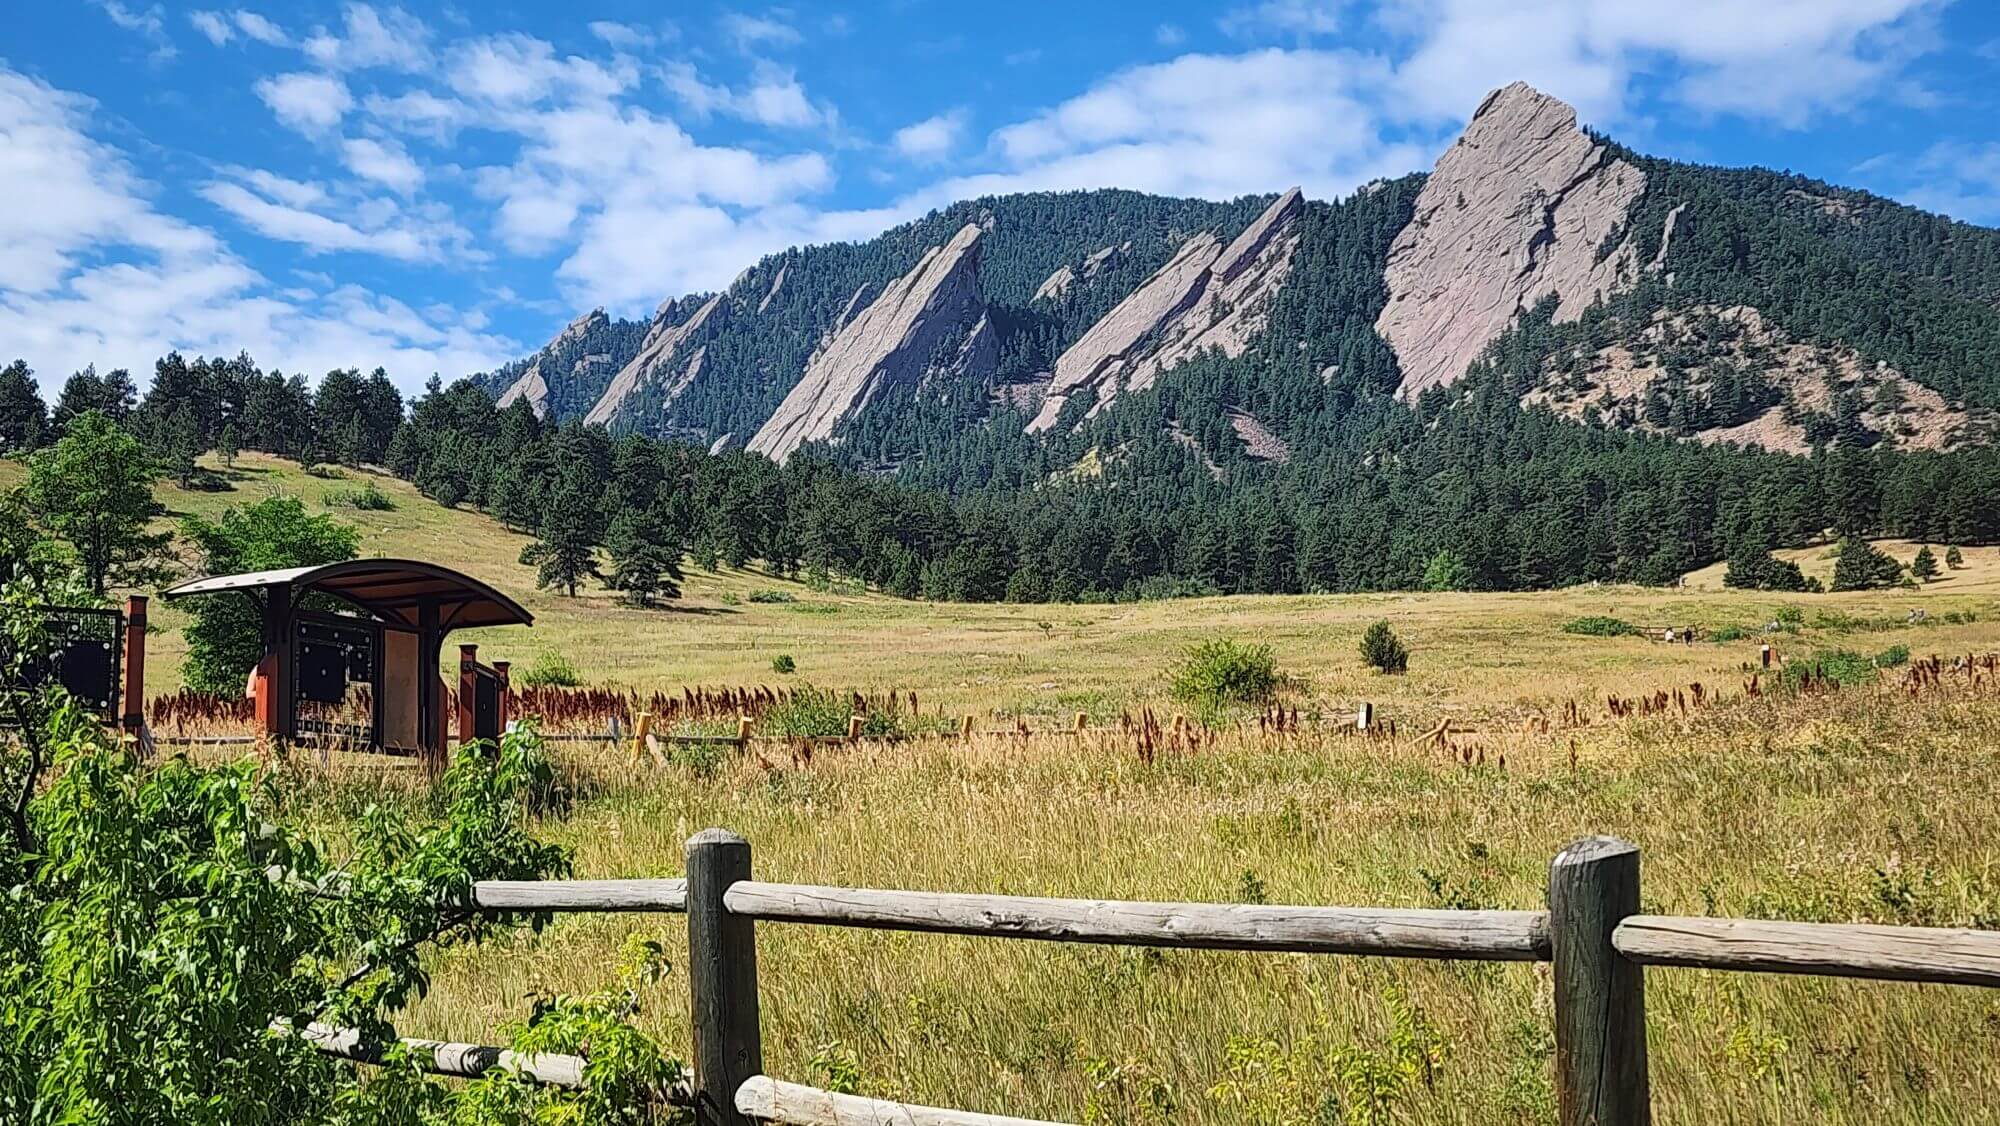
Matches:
[376,686,2000,1124]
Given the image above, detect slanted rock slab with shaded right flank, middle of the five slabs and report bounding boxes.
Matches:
[748,224,998,462]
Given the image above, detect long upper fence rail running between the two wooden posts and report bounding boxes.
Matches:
[722,880,1548,962]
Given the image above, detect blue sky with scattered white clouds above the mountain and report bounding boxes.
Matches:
[0,0,2000,392]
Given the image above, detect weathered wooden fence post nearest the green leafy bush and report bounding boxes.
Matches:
[688,828,764,1126]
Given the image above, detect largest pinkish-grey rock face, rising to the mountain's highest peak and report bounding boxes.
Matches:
[1376,82,1646,398]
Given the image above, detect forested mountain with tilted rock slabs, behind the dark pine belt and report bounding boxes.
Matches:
[478,84,2000,480]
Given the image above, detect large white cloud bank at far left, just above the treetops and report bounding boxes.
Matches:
[0,68,522,394]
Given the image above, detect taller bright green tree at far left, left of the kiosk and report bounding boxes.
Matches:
[24,410,168,596]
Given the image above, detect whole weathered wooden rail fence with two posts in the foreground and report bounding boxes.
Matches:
[306,828,2000,1126]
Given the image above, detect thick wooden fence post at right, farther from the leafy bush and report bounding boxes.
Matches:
[1548,836,1652,1126]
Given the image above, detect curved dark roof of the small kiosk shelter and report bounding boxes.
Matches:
[160,560,534,630]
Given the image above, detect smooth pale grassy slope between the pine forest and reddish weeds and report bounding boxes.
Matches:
[0,454,2000,720]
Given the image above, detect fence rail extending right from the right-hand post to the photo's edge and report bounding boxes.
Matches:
[1612,914,2000,986]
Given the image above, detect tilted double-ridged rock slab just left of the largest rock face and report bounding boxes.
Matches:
[1028,188,1306,432]
